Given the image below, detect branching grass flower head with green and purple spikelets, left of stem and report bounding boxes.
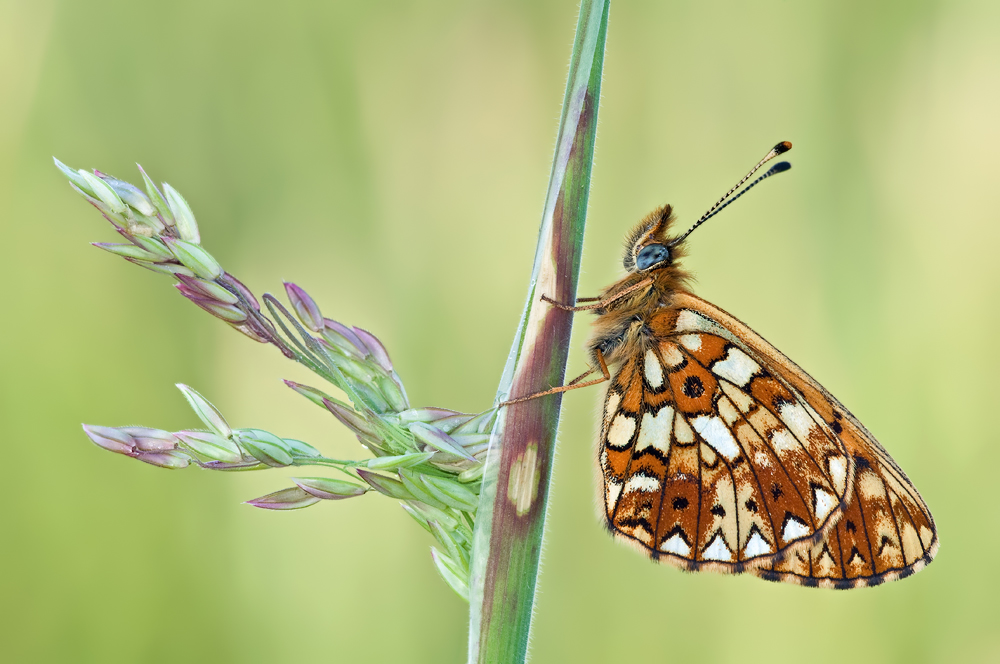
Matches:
[55,160,497,597]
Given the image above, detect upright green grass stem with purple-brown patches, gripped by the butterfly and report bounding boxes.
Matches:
[468,0,609,664]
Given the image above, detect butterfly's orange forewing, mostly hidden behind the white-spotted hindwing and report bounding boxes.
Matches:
[675,293,938,588]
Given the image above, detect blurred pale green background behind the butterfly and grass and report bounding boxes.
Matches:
[0,0,1000,664]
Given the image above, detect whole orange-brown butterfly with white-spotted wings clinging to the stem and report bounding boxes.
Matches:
[508,142,938,588]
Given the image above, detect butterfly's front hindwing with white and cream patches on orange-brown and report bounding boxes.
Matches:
[600,301,854,572]
